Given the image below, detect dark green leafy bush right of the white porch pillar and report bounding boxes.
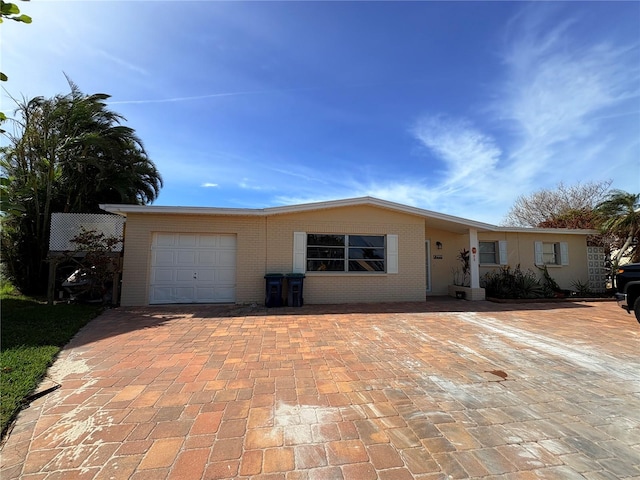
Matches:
[480,265,544,298]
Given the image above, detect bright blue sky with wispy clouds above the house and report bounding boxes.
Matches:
[0,0,640,223]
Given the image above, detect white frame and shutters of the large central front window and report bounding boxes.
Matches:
[292,232,399,275]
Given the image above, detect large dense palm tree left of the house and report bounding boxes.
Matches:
[0,78,162,293]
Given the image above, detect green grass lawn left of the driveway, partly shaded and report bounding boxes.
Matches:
[0,289,102,436]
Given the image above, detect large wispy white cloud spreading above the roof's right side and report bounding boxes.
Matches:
[407,8,640,221]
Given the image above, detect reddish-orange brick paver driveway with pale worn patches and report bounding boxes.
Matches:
[1,299,640,480]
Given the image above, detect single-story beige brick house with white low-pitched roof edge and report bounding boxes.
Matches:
[101,197,595,306]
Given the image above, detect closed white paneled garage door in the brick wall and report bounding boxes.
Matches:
[149,233,236,304]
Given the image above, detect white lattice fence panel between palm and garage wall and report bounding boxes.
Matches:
[49,213,125,252]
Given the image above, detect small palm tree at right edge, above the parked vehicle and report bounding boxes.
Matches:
[596,190,640,265]
